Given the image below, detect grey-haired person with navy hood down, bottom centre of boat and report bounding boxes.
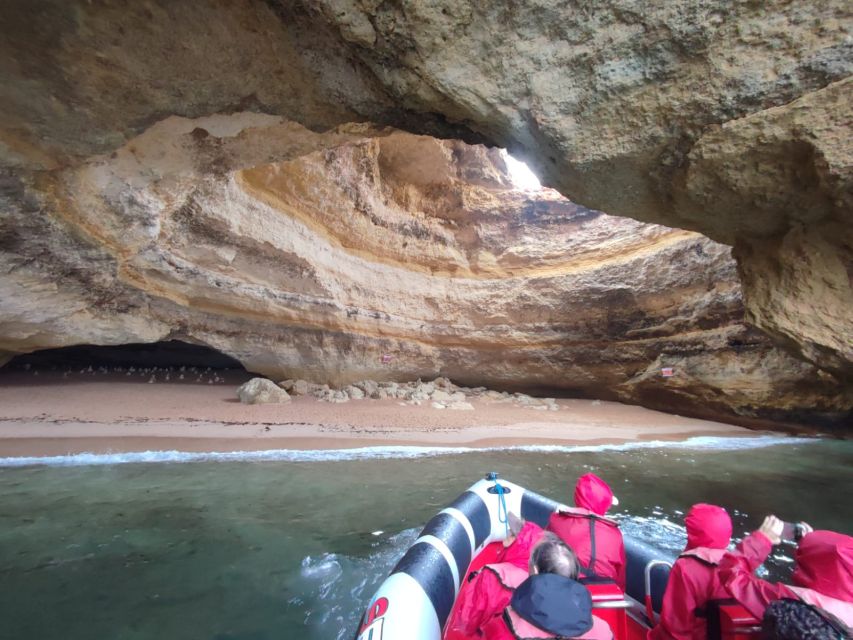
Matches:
[482,533,613,640]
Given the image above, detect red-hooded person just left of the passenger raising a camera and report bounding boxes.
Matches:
[647,504,732,640]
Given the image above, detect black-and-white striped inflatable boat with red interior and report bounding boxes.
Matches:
[355,473,759,640]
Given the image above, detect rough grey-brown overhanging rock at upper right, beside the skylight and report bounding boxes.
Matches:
[312,0,853,376]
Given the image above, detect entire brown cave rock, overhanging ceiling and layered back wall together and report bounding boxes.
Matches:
[0,0,853,430]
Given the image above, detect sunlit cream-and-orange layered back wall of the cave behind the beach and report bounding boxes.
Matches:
[0,113,853,425]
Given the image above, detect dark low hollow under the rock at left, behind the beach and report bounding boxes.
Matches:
[2,340,250,384]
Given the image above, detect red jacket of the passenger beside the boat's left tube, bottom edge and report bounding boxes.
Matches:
[445,564,528,640]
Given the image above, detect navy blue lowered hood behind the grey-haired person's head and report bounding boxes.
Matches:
[510,573,592,638]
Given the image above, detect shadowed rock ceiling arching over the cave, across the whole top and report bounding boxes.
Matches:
[0,0,853,375]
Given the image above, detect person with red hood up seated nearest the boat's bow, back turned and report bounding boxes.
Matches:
[546,473,626,591]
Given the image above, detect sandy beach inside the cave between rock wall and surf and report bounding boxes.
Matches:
[0,371,756,457]
